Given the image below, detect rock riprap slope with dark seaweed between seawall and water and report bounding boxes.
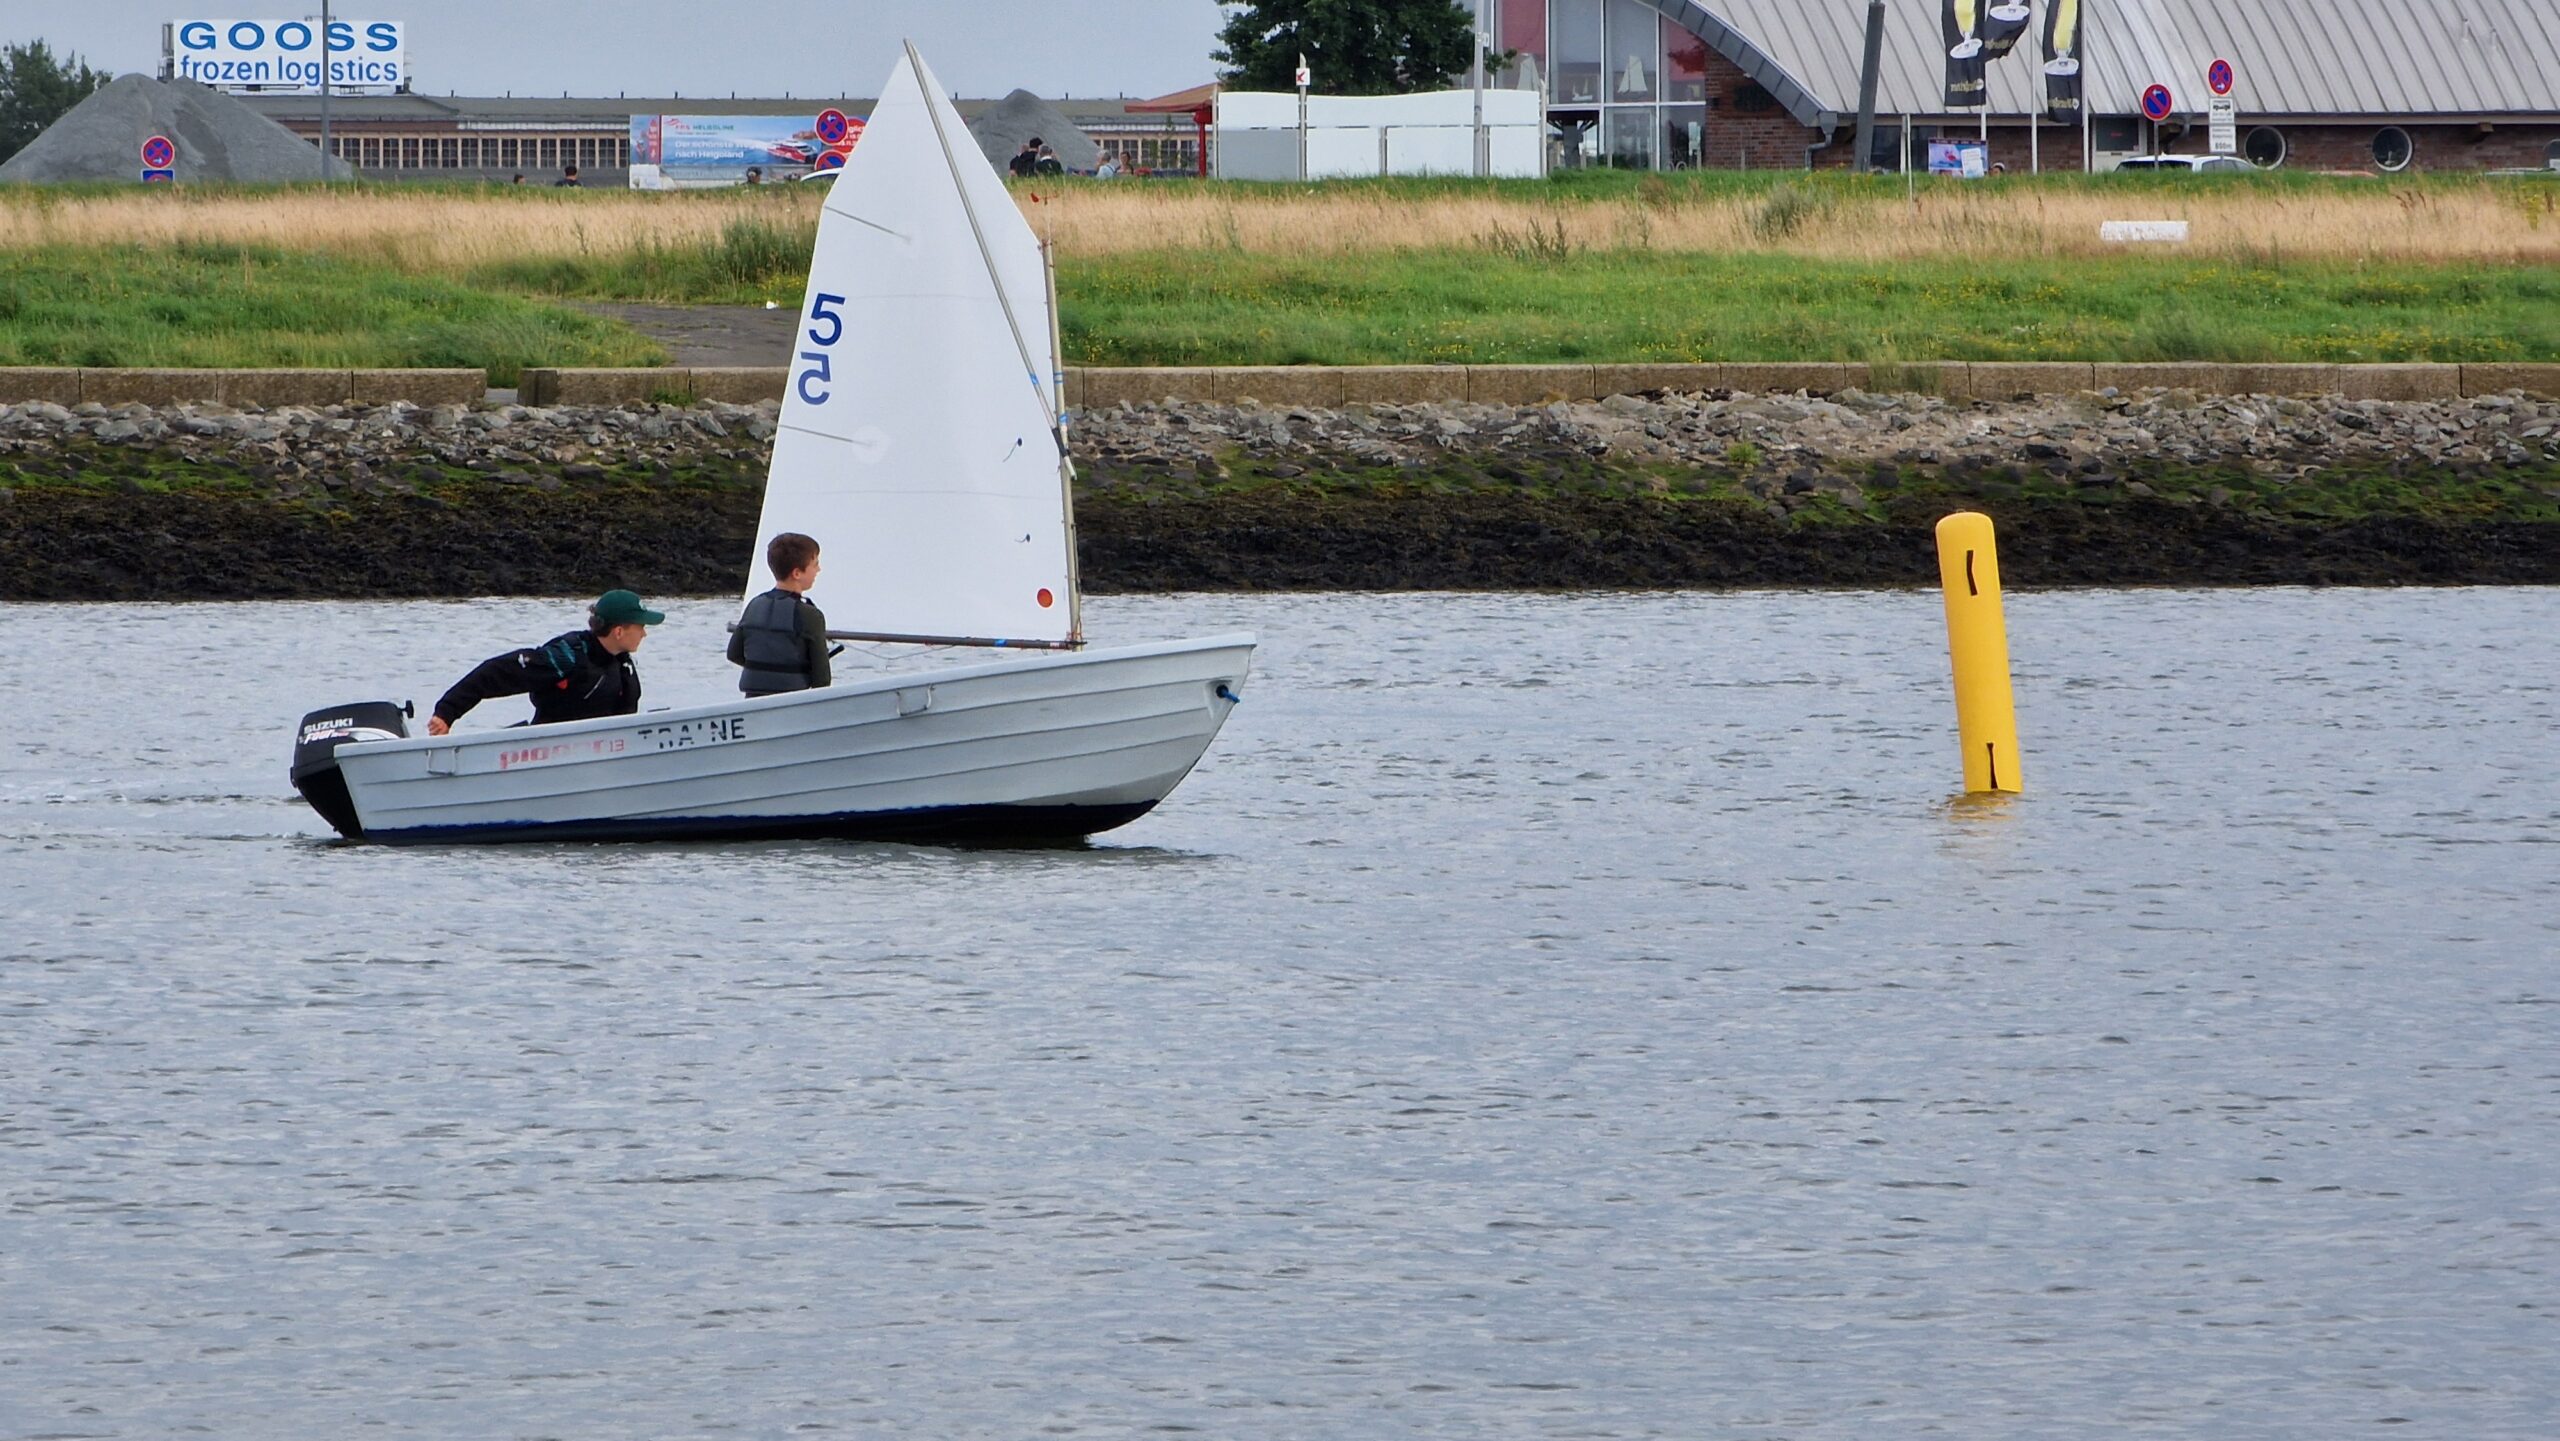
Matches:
[0,392,2560,599]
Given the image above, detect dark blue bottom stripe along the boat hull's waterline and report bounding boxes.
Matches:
[361,801,1155,845]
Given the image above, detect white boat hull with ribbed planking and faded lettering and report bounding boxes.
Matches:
[320,635,1254,845]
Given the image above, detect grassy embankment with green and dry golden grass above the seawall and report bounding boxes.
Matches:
[0,174,2560,384]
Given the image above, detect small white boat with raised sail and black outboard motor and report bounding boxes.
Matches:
[292,46,1254,842]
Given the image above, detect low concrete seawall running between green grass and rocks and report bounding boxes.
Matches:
[0,361,2560,410]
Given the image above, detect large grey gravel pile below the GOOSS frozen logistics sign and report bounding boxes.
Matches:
[0,74,351,184]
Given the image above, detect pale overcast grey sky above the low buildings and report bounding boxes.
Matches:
[22,0,1221,100]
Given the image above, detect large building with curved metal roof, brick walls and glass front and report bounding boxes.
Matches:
[1492,0,2560,171]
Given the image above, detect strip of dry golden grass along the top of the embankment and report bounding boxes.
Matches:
[0,179,2560,274]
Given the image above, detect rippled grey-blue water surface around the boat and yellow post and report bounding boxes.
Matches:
[0,591,2560,1438]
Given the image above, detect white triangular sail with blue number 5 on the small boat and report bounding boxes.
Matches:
[748,49,1080,645]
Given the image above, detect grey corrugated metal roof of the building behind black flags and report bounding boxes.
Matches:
[1646,0,2560,125]
